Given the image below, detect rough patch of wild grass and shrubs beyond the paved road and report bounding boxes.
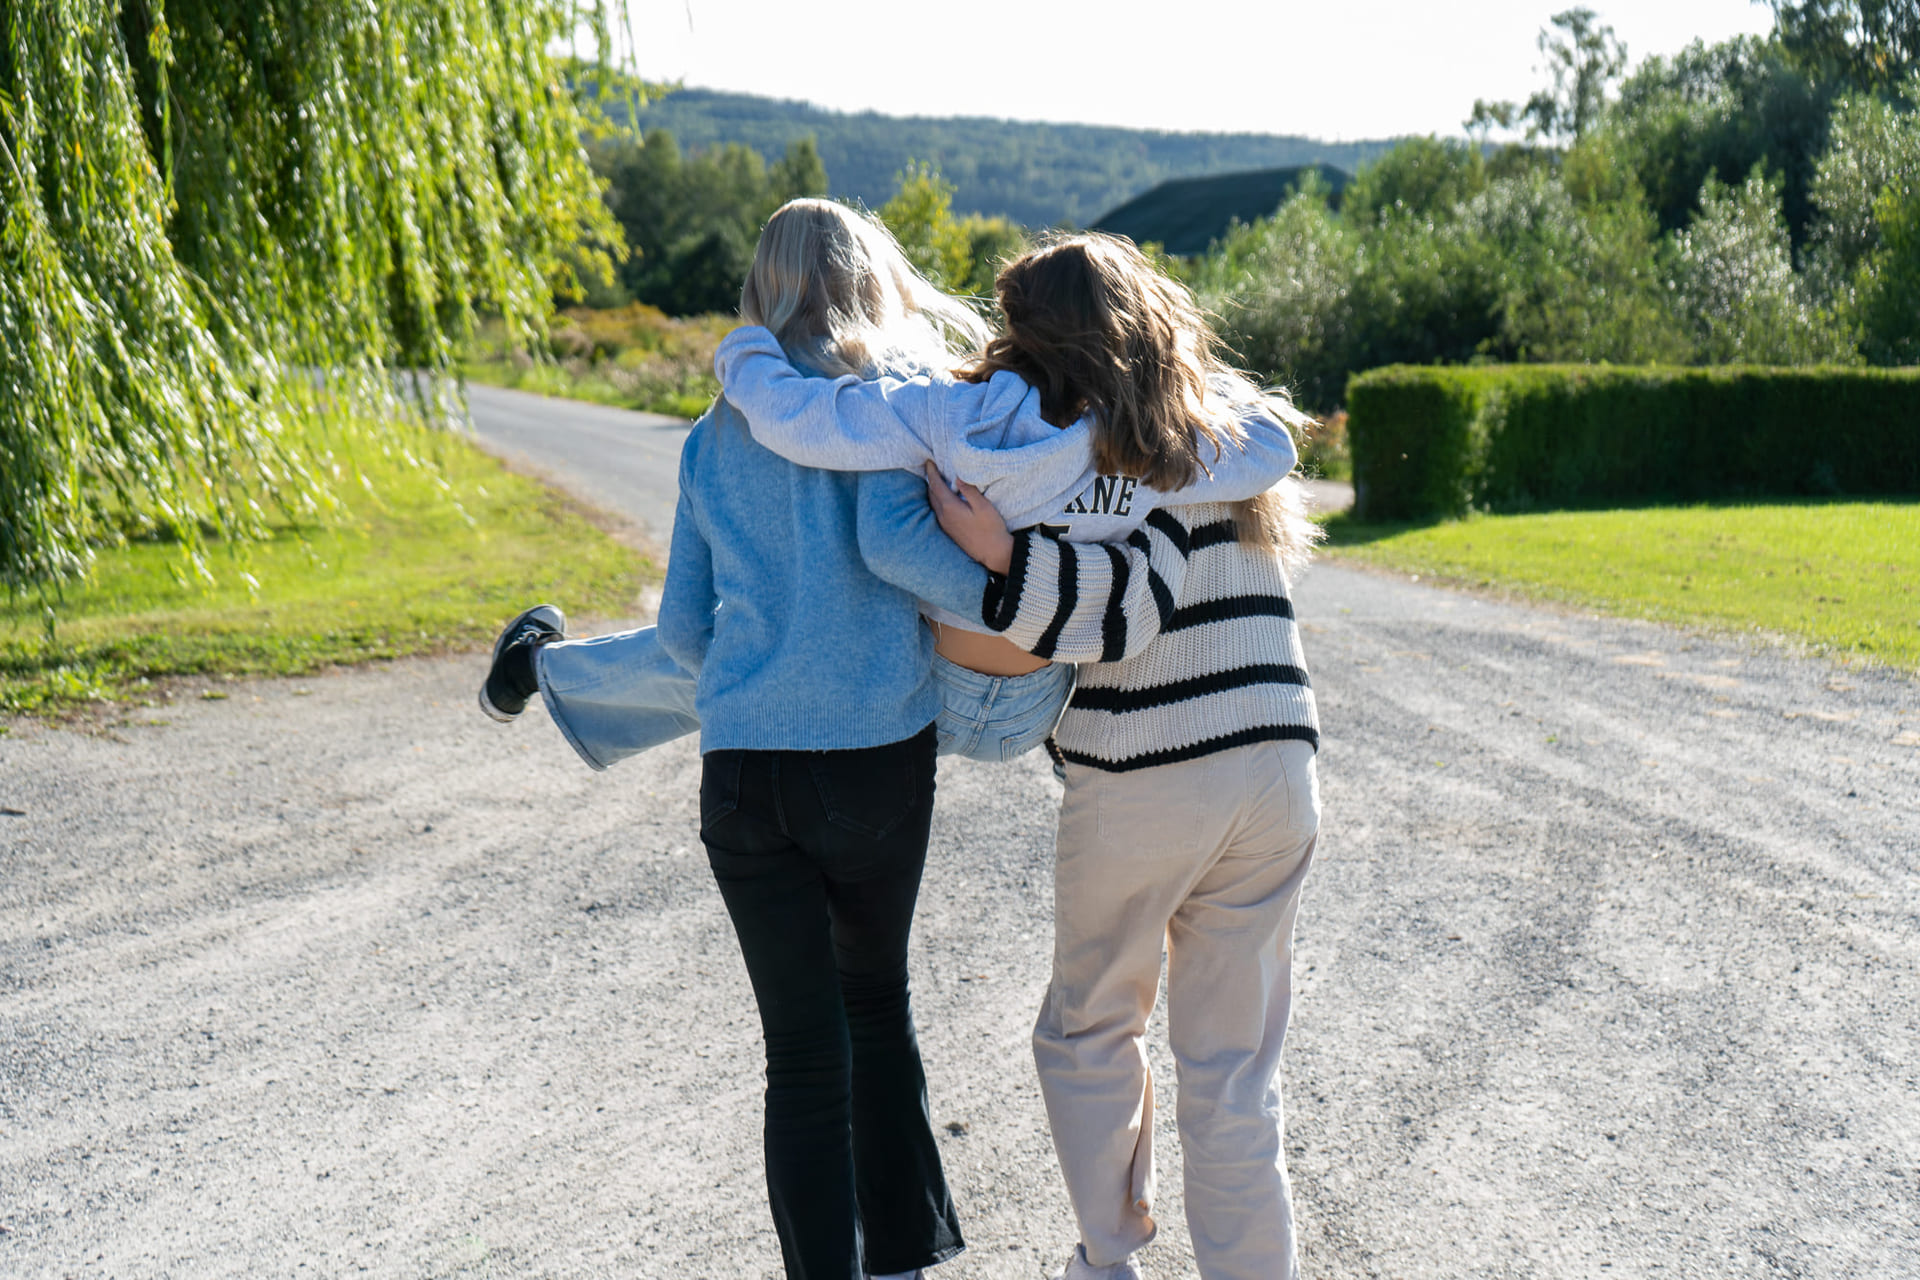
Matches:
[461,303,739,418]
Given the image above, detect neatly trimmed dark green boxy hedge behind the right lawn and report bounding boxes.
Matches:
[1346,365,1920,520]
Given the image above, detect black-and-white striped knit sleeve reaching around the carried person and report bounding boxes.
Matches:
[981,507,1192,662]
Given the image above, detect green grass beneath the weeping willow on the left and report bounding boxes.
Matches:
[0,428,655,712]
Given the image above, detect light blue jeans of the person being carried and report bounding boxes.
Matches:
[534,628,1073,770]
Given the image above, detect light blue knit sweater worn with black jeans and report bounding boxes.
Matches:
[659,399,987,752]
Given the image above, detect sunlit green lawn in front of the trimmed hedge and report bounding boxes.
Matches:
[1329,501,1920,670]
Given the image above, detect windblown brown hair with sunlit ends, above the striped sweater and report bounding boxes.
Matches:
[960,232,1325,566]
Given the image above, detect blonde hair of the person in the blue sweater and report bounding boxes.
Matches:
[739,200,987,376]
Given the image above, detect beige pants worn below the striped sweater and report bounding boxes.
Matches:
[1033,743,1319,1280]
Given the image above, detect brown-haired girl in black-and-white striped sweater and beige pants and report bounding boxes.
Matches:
[716,236,1319,1280]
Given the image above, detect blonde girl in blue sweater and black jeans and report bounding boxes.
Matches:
[622,201,1029,1280]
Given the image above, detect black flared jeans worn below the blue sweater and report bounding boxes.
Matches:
[701,725,964,1280]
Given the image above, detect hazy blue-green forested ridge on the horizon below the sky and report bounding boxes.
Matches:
[622,88,1390,226]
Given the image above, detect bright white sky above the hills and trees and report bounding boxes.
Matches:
[628,0,1772,140]
